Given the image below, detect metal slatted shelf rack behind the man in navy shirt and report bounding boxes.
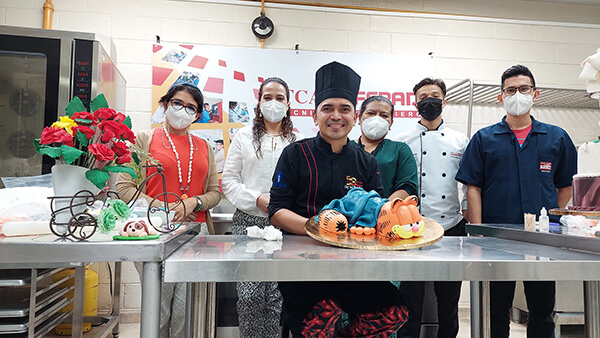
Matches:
[446,79,598,137]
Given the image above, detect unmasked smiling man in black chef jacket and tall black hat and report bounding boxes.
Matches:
[269,62,407,337]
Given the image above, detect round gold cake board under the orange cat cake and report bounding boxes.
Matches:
[304,217,444,251]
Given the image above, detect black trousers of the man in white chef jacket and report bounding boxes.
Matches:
[398,219,467,338]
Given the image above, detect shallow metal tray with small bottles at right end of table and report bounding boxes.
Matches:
[466,224,600,253]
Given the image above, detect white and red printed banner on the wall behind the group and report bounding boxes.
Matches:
[152,43,433,164]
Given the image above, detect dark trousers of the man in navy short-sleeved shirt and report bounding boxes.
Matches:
[490,281,556,338]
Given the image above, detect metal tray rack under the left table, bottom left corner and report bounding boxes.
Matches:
[0,268,74,337]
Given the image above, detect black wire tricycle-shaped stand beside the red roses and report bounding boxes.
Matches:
[48,164,186,240]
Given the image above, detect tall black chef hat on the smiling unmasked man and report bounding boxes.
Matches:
[315,61,360,107]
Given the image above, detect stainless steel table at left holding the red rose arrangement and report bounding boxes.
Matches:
[0,225,200,338]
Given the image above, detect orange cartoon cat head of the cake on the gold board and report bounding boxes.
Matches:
[377,195,425,239]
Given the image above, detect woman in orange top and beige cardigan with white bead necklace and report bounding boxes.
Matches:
[116,80,221,337]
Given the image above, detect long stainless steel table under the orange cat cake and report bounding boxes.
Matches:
[164,235,600,338]
